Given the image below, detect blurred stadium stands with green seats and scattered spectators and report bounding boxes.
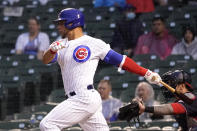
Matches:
[0,0,197,131]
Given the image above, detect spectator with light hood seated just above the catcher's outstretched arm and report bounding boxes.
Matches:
[135,82,162,121]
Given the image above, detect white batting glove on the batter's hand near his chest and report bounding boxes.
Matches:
[49,40,65,54]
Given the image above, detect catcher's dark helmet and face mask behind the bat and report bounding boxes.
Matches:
[161,70,194,98]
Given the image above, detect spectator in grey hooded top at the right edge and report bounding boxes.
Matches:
[171,26,197,60]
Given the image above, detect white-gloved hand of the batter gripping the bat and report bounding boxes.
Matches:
[144,70,161,85]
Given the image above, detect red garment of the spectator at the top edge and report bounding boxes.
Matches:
[126,0,155,13]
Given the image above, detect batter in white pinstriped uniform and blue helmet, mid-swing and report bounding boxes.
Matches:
[40,8,161,131]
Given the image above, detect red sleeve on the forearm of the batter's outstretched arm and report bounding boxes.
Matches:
[122,57,148,76]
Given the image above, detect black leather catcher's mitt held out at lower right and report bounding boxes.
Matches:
[118,100,140,122]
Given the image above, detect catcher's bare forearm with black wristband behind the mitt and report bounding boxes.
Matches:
[145,104,174,115]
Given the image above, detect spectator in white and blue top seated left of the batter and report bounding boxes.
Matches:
[15,17,49,60]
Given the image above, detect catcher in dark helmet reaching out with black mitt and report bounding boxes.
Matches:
[119,70,197,131]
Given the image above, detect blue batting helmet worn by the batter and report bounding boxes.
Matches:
[54,8,84,30]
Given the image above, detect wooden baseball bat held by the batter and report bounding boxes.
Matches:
[160,81,193,105]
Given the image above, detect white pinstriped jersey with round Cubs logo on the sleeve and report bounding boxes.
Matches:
[57,35,111,93]
